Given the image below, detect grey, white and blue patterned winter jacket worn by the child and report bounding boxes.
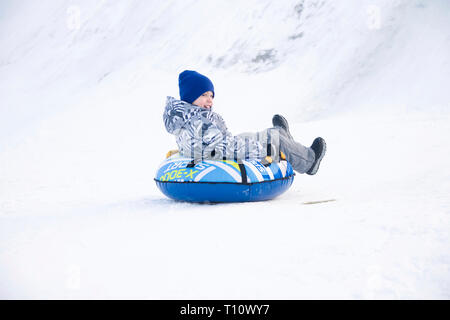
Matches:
[163,97,267,160]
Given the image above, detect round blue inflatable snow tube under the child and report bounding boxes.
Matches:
[155,153,295,202]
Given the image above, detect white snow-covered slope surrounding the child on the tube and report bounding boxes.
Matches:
[0,0,450,299]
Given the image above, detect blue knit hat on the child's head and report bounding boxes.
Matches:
[178,70,214,103]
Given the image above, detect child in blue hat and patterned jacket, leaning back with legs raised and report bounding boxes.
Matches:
[163,70,326,175]
